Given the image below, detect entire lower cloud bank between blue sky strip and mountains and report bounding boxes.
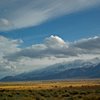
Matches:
[0,35,100,76]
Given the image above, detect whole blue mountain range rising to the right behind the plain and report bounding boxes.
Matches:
[1,61,100,81]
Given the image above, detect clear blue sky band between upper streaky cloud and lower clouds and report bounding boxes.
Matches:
[0,6,100,47]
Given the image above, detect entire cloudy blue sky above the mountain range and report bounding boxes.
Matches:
[0,0,100,78]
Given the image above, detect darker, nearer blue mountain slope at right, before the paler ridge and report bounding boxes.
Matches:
[48,64,100,79]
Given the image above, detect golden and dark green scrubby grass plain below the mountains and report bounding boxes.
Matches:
[0,80,100,100]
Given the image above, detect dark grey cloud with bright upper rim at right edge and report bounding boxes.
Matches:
[73,36,100,54]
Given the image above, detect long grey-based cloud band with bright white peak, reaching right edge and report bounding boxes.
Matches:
[5,35,100,60]
